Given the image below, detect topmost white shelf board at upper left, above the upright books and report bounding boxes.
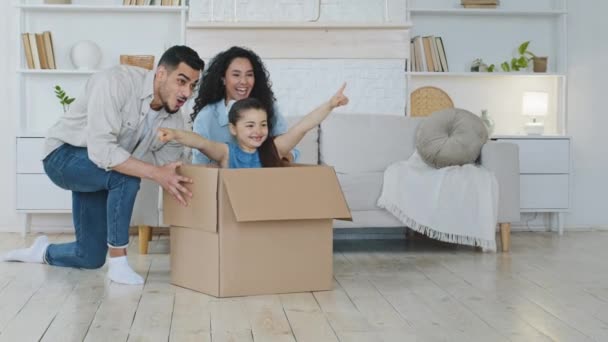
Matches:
[17,5,188,12]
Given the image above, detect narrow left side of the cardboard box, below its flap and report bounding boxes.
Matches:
[171,227,219,297]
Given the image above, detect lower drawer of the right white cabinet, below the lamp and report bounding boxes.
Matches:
[519,174,569,209]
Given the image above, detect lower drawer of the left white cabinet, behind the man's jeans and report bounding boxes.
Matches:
[17,174,72,210]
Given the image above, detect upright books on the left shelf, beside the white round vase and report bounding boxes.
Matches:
[21,31,57,69]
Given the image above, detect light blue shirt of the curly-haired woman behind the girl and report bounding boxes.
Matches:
[192,100,300,164]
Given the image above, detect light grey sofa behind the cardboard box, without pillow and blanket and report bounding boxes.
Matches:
[287,114,520,251]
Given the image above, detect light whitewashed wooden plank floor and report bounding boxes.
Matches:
[0,231,608,342]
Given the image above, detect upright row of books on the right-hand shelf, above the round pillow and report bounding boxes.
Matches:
[409,36,449,72]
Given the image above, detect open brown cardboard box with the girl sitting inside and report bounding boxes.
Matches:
[163,165,351,297]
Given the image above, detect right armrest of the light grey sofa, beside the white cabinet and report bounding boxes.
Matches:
[481,141,520,223]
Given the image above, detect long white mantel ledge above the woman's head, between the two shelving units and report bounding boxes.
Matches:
[186,21,412,30]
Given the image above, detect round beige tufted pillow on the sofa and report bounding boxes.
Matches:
[416,108,488,168]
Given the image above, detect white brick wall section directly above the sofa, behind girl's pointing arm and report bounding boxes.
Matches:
[264,59,405,115]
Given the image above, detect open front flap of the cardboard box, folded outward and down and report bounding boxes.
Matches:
[220,166,352,222]
